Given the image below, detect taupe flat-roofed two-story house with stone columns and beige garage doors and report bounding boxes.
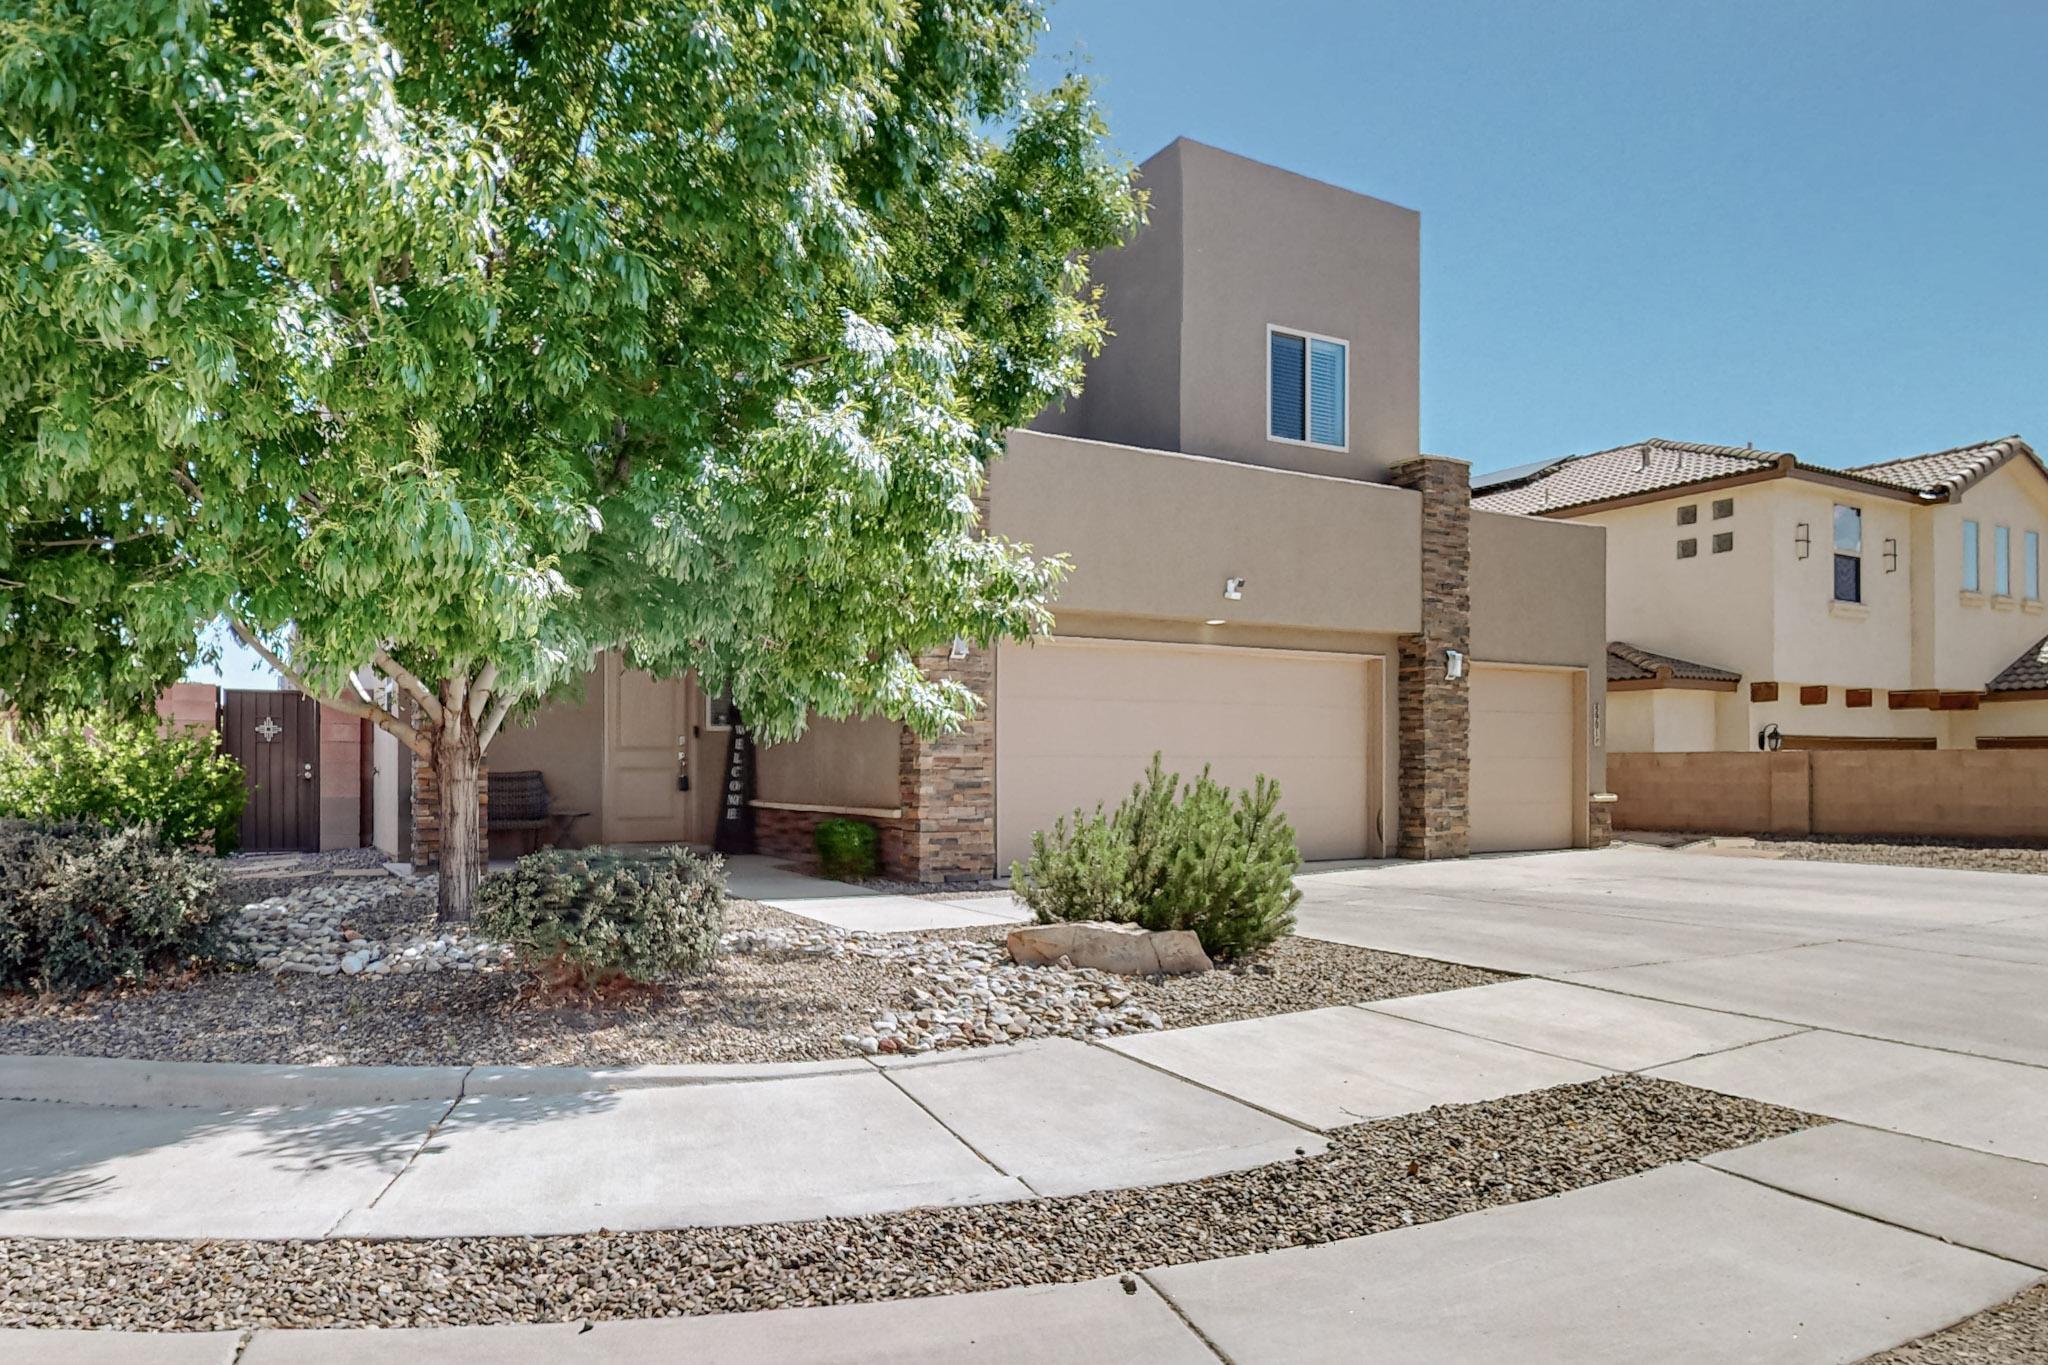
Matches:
[379,141,1606,880]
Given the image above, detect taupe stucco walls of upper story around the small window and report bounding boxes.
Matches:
[1034,139,1421,479]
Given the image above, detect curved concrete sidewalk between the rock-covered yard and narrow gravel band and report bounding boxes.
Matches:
[0,1040,1327,1238]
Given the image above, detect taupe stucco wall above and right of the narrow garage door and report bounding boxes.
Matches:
[1473,510,1608,790]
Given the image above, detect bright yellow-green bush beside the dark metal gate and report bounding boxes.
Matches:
[0,712,248,853]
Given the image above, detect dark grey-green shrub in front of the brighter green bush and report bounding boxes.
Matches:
[0,821,223,990]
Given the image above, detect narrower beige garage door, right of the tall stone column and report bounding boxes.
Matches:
[1470,665,1579,853]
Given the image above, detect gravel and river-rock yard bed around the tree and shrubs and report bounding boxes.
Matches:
[0,876,1503,1066]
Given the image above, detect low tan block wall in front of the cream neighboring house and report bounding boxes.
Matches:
[1608,749,2048,839]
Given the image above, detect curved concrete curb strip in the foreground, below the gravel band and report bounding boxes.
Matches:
[12,1154,2042,1365]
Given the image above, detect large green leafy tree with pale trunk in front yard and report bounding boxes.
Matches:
[0,0,1139,917]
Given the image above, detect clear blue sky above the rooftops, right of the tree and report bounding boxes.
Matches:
[1042,0,2048,471]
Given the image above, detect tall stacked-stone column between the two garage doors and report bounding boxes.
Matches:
[1391,454,1473,857]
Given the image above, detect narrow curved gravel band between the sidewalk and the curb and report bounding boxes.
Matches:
[0,1076,1821,1330]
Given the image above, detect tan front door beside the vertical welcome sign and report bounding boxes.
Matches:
[604,653,700,843]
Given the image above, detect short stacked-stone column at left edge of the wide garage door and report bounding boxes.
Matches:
[893,647,995,882]
